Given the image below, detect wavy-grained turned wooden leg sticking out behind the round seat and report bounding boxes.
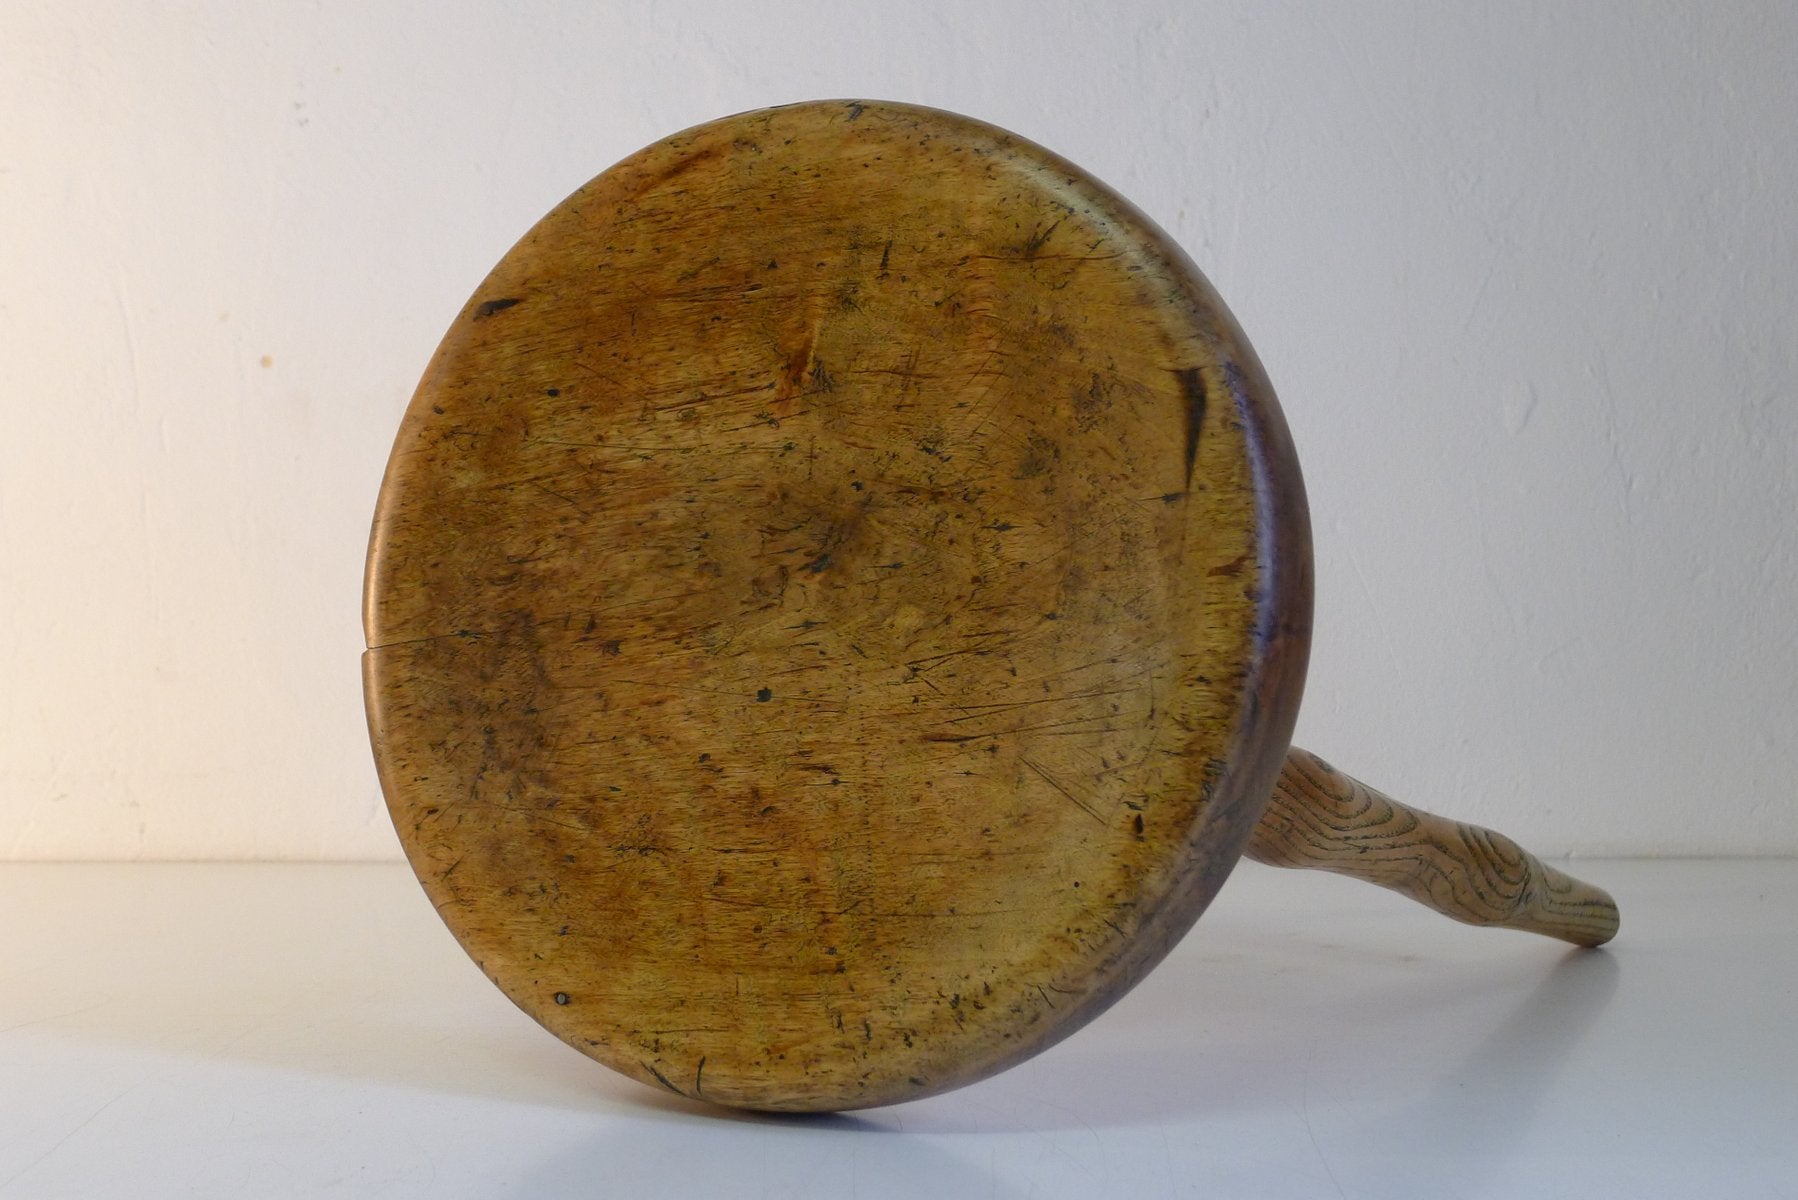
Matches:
[1248,747,1616,946]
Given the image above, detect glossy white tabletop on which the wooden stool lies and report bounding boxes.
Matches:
[0,860,1798,1200]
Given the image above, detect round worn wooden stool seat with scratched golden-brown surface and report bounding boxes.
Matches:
[365,103,1311,1108]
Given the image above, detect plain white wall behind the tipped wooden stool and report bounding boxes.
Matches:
[0,0,1798,858]
